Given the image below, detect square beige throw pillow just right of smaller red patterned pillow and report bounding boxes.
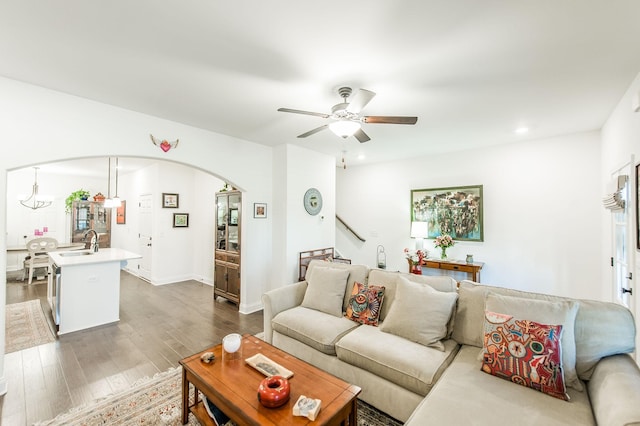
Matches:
[380,276,458,350]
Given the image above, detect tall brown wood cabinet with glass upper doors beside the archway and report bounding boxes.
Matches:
[213,191,242,304]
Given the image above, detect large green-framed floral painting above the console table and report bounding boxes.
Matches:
[411,185,484,241]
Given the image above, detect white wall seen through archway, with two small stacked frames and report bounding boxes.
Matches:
[106,161,224,285]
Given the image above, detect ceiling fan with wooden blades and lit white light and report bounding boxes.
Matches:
[278,87,418,143]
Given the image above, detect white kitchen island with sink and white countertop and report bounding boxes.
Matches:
[47,248,142,334]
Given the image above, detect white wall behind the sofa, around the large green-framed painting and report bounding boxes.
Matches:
[336,132,603,299]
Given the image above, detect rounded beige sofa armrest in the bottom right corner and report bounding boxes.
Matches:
[587,354,640,426]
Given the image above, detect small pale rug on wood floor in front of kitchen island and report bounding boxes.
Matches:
[5,299,56,353]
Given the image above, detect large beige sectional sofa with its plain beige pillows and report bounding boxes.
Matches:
[263,261,640,425]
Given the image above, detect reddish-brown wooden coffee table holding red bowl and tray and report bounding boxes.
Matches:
[180,335,360,426]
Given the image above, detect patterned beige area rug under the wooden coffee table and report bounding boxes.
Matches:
[35,368,402,426]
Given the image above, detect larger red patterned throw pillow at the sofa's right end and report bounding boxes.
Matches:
[482,311,569,401]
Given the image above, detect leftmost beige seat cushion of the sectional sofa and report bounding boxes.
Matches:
[271,306,359,355]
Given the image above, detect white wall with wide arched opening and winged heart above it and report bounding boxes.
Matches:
[0,78,281,394]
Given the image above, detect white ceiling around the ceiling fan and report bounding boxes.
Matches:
[0,0,640,168]
